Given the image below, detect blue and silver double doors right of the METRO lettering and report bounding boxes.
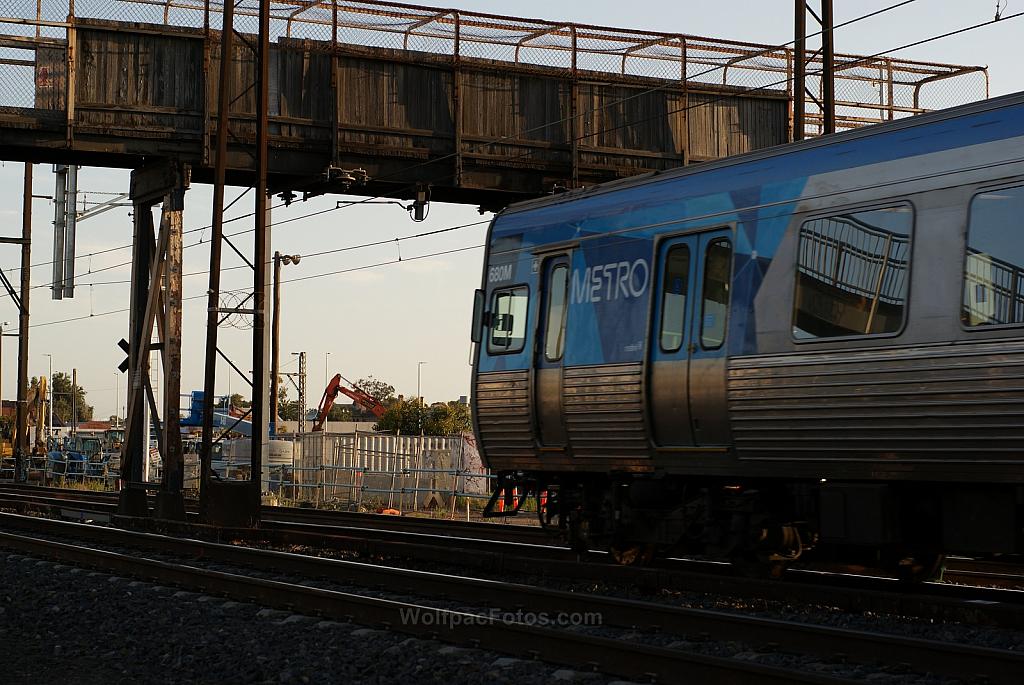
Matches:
[648,229,732,446]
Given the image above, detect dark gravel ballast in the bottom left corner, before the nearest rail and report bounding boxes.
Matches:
[0,551,616,685]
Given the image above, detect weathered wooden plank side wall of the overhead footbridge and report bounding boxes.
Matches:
[0,19,790,207]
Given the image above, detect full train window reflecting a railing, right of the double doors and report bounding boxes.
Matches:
[793,205,913,340]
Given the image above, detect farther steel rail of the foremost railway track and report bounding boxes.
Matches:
[0,515,1024,683]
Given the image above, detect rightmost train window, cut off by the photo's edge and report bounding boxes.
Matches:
[961,186,1024,327]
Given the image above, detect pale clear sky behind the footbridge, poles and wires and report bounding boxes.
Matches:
[0,0,1024,418]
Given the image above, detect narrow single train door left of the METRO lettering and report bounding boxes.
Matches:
[534,255,569,447]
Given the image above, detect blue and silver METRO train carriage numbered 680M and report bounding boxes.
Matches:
[472,88,1024,579]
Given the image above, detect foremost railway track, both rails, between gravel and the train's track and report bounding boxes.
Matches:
[0,514,1024,683]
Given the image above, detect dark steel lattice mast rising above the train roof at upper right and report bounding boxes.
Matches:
[793,0,836,141]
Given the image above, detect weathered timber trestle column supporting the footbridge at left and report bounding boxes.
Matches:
[119,163,188,519]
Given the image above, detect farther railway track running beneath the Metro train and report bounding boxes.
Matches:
[0,487,1024,629]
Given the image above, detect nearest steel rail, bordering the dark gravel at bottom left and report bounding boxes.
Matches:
[0,520,851,685]
